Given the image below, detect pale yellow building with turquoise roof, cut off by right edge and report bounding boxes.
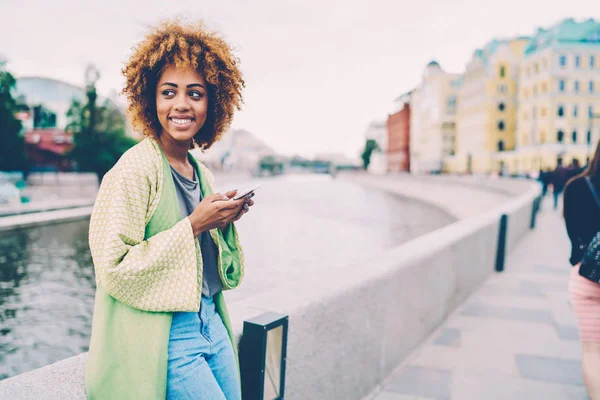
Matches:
[502,19,600,173]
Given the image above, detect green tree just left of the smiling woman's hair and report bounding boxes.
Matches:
[67,69,136,180]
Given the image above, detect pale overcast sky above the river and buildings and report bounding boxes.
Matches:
[0,0,600,157]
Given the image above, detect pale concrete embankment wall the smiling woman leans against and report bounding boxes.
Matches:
[0,179,540,400]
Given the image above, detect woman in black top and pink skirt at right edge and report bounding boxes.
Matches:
[564,142,600,400]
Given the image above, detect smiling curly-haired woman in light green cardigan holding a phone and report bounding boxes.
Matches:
[85,22,254,400]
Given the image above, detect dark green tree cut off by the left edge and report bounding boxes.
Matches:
[0,60,27,172]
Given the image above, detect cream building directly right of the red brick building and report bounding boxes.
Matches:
[410,61,458,173]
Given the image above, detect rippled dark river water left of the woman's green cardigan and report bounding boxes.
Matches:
[0,221,95,379]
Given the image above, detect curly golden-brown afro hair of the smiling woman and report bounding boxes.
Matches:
[122,20,244,150]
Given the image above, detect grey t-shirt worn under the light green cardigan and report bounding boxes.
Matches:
[171,167,223,297]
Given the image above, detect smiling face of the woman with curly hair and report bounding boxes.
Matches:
[156,66,208,143]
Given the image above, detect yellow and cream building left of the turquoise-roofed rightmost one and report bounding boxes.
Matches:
[445,37,529,173]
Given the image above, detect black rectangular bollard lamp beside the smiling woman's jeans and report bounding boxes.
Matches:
[240,312,288,400]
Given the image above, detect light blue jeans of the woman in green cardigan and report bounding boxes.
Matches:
[167,296,242,400]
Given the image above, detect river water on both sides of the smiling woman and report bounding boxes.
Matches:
[0,175,454,379]
